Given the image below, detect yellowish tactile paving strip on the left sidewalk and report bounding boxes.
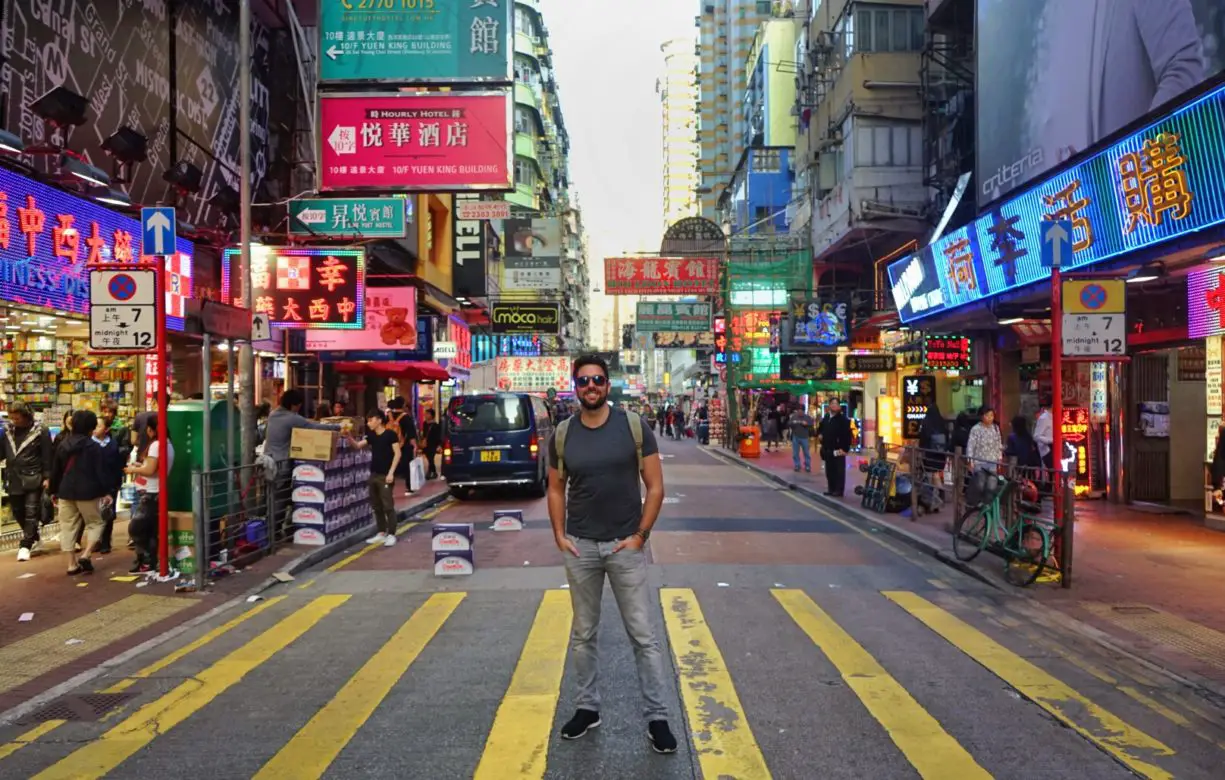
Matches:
[0,595,195,693]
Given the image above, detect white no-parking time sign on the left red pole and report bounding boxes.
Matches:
[89,267,157,354]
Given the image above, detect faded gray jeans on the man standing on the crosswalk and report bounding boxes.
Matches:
[566,536,668,721]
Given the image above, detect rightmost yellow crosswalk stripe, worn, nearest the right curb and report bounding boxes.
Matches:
[882,590,1174,778]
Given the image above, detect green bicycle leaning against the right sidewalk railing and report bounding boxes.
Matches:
[953,476,1057,588]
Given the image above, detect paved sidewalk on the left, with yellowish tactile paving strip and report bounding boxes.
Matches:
[0,480,448,719]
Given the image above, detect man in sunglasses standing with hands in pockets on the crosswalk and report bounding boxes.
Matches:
[549,355,676,753]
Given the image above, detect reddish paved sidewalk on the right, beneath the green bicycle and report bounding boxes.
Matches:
[708,447,1225,692]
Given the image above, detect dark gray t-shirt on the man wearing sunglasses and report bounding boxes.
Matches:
[549,409,659,541]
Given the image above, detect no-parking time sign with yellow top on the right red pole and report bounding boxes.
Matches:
[1060,279,1127,358]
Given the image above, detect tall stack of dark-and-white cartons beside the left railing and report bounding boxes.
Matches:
[293,431,371,545]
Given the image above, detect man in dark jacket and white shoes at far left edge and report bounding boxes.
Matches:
[0,402,51,561]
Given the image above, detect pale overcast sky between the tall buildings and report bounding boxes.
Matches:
[540,0,698,340]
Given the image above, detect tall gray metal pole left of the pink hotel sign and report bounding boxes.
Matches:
[240,0,255,475]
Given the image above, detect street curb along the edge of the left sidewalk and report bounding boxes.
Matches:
[0,491,451,726]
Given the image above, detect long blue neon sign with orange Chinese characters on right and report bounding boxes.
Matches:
[888,79,1225,322]
